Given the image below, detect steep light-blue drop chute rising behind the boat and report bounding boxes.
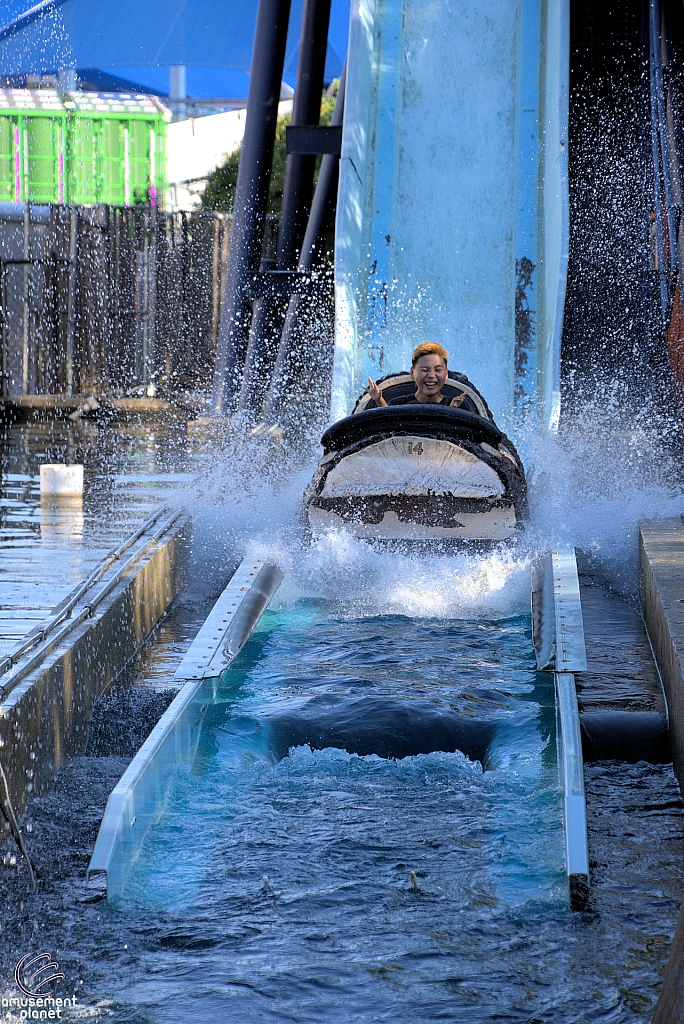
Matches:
[332,0,569,431]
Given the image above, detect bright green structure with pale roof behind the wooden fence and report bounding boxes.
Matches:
[0,89,170,206]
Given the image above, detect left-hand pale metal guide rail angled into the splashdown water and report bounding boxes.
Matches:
[87,559,283,898]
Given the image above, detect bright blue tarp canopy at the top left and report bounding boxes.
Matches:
[0,0,349,96]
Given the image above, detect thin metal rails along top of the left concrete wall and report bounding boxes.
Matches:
[0,507,185,700]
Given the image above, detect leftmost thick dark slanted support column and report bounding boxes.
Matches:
[211,0,291,416]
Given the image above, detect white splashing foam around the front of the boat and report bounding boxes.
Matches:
[174,410,684,618]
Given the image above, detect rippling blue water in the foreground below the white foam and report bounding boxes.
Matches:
[0,594,684,1024]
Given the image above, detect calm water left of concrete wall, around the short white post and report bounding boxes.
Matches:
[0,422,194,653]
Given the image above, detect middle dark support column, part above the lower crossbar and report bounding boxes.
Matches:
[276,0,331,270]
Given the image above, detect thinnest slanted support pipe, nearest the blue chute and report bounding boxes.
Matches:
[264,65,347,421]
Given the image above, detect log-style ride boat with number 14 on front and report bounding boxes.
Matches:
[303,371,527,544]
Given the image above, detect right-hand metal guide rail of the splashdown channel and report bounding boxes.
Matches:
[532,548,589,910]
